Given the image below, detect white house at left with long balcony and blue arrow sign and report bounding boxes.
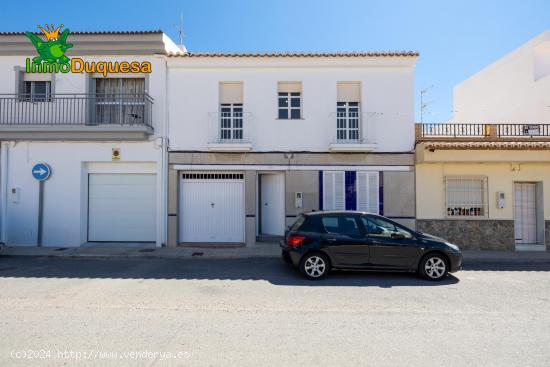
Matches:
[0,31,179,247]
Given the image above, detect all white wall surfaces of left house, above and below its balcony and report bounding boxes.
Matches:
[0,47,174,246]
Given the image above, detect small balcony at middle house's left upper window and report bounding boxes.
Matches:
[208,108,252,152]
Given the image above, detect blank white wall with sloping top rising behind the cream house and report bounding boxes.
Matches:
[450,31,550,123]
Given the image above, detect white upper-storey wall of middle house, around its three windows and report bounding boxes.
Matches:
[168,57,416,152]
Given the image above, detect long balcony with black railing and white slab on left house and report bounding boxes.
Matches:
[0,94,153,140]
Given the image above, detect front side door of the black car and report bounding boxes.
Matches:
[361,215,420,269]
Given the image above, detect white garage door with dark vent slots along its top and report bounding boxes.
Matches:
[179,173,244,242]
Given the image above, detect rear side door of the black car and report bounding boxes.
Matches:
[321,214,369,267]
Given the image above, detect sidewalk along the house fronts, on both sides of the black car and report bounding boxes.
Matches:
[2,242,550,263]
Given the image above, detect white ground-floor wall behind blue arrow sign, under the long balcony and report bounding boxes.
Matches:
[2,142,159,246]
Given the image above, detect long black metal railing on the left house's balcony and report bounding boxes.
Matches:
[0,93,153,127]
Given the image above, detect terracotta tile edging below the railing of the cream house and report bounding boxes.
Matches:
[421,141,550,150]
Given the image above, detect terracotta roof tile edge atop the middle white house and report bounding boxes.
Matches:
[168,51,419,57]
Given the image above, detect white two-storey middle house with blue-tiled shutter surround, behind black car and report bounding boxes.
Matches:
[167,52,418,246]
